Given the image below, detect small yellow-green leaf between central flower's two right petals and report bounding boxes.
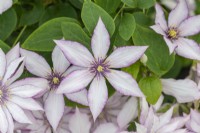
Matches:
[122,62,140,79]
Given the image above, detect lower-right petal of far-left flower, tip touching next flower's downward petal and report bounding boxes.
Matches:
[10,95,43,110]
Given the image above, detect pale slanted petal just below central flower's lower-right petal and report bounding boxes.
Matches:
[117,97,138,129]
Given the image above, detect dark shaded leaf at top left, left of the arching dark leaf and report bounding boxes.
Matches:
[19,0,45,26]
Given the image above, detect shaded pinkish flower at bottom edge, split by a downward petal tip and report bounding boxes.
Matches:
[15,107,74,133]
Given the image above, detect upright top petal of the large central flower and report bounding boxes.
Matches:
[91,18,110,59]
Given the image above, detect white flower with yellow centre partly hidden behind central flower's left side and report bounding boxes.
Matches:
[20,47,88,130]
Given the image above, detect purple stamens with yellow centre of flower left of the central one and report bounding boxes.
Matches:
[47,72,63,89]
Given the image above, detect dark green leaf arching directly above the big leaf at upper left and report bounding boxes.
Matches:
[39,3,77,25]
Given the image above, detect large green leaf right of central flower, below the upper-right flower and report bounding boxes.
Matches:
[132,25,175,76]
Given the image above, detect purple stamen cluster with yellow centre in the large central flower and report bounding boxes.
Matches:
[90,59,110,76]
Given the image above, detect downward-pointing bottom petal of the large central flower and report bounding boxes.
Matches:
[88,76,108,121]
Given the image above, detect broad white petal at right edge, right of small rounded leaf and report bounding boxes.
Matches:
[161,79,200,103]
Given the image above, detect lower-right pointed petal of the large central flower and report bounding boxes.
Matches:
[106,70,144,97]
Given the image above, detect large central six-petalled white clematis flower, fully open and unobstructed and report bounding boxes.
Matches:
[55,18,147,120]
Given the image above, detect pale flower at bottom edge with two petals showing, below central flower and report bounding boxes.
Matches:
[93,97,138,133]
